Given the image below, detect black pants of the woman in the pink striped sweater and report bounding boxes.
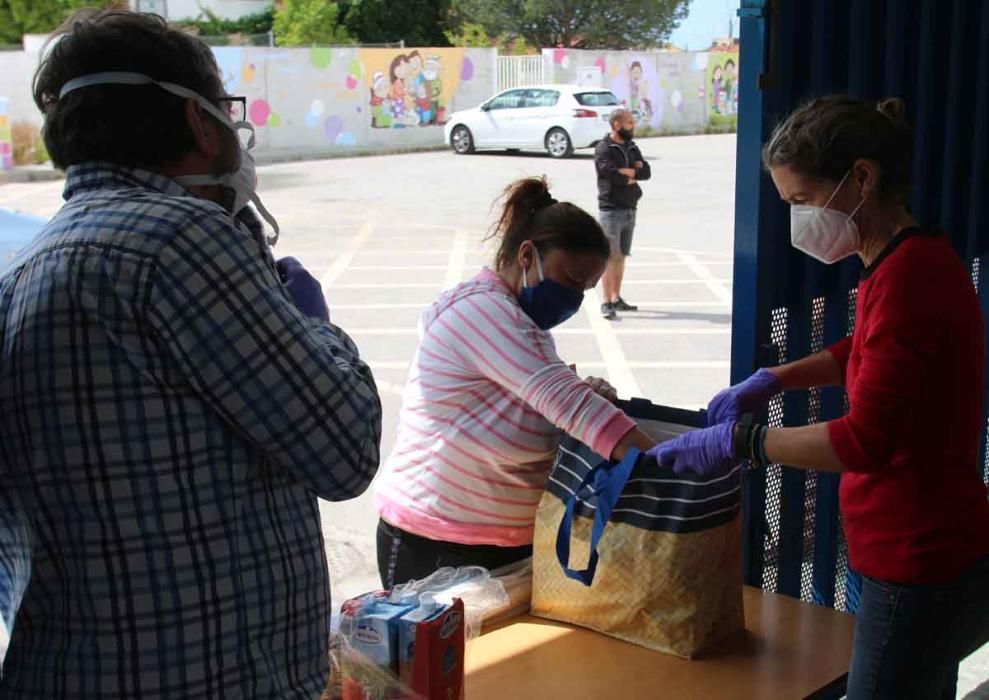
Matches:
[378,520,532,588]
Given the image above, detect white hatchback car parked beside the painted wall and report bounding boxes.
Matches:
[444,85,622,158]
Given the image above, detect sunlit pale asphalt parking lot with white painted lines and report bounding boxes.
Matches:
[0,135,989,698]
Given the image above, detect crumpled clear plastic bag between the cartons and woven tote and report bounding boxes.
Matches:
[388,566,511,639]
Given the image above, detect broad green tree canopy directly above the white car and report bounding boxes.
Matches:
[451,0,690,49]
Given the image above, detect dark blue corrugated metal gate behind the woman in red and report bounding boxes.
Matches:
[732,0,989,611]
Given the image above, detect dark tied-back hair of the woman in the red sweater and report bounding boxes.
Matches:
[762,95,913,205]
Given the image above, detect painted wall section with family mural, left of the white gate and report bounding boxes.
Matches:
[207,47,496,156]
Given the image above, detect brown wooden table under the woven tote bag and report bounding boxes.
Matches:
[465,587,854,700]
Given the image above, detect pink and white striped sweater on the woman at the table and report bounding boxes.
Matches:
[375,269,634,547]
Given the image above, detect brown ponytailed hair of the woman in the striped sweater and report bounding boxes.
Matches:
[488,177,611,270]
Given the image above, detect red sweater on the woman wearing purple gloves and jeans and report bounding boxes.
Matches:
[828,229,989,584]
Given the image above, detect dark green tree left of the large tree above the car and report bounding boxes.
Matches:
[346,0,450,46]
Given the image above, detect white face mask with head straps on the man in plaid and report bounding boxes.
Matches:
[58,71,279,246]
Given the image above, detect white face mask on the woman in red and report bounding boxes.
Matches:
[790,170,865,265]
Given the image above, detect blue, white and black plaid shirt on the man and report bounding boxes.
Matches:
[0,164,381,700]
